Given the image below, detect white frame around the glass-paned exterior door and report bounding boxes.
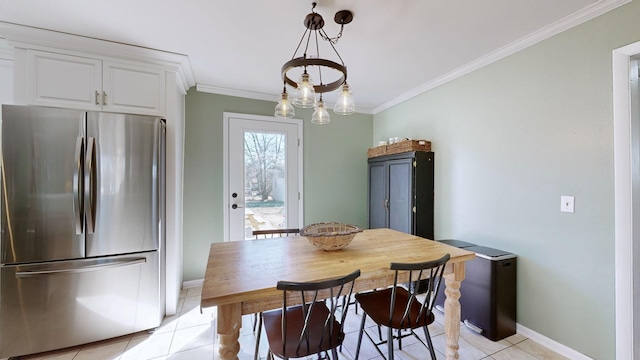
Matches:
[222,112,304,241]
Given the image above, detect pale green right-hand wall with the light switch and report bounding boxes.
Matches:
[373,2,640,359]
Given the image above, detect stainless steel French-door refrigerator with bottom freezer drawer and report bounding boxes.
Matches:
[0,105,165,358]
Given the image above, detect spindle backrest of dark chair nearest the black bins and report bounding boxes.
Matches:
[389,254,450,328]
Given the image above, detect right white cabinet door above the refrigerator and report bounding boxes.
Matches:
[103,61,166,116]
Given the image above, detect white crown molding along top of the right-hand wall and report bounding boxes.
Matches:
[373,0,632,114]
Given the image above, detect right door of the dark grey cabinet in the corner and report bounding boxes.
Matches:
[388,158,414,234]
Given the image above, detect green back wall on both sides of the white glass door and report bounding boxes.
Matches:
[184,89,373,280]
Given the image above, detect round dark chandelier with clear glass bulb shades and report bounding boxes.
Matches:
[275,2,355,124]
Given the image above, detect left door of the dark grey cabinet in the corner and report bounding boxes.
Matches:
[369,162,388,229]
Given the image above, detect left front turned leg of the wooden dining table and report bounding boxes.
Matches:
[217,303,242,360]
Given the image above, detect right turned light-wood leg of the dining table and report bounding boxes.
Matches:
[444,262,464,360]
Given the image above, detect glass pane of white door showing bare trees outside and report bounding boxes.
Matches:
[244,131,286,230]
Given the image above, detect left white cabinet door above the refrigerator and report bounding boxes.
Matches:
[27,50,102,110]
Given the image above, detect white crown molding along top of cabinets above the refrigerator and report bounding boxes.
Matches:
[0,21,195,92]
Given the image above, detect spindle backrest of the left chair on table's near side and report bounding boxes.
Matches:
[277,270,360,357]
